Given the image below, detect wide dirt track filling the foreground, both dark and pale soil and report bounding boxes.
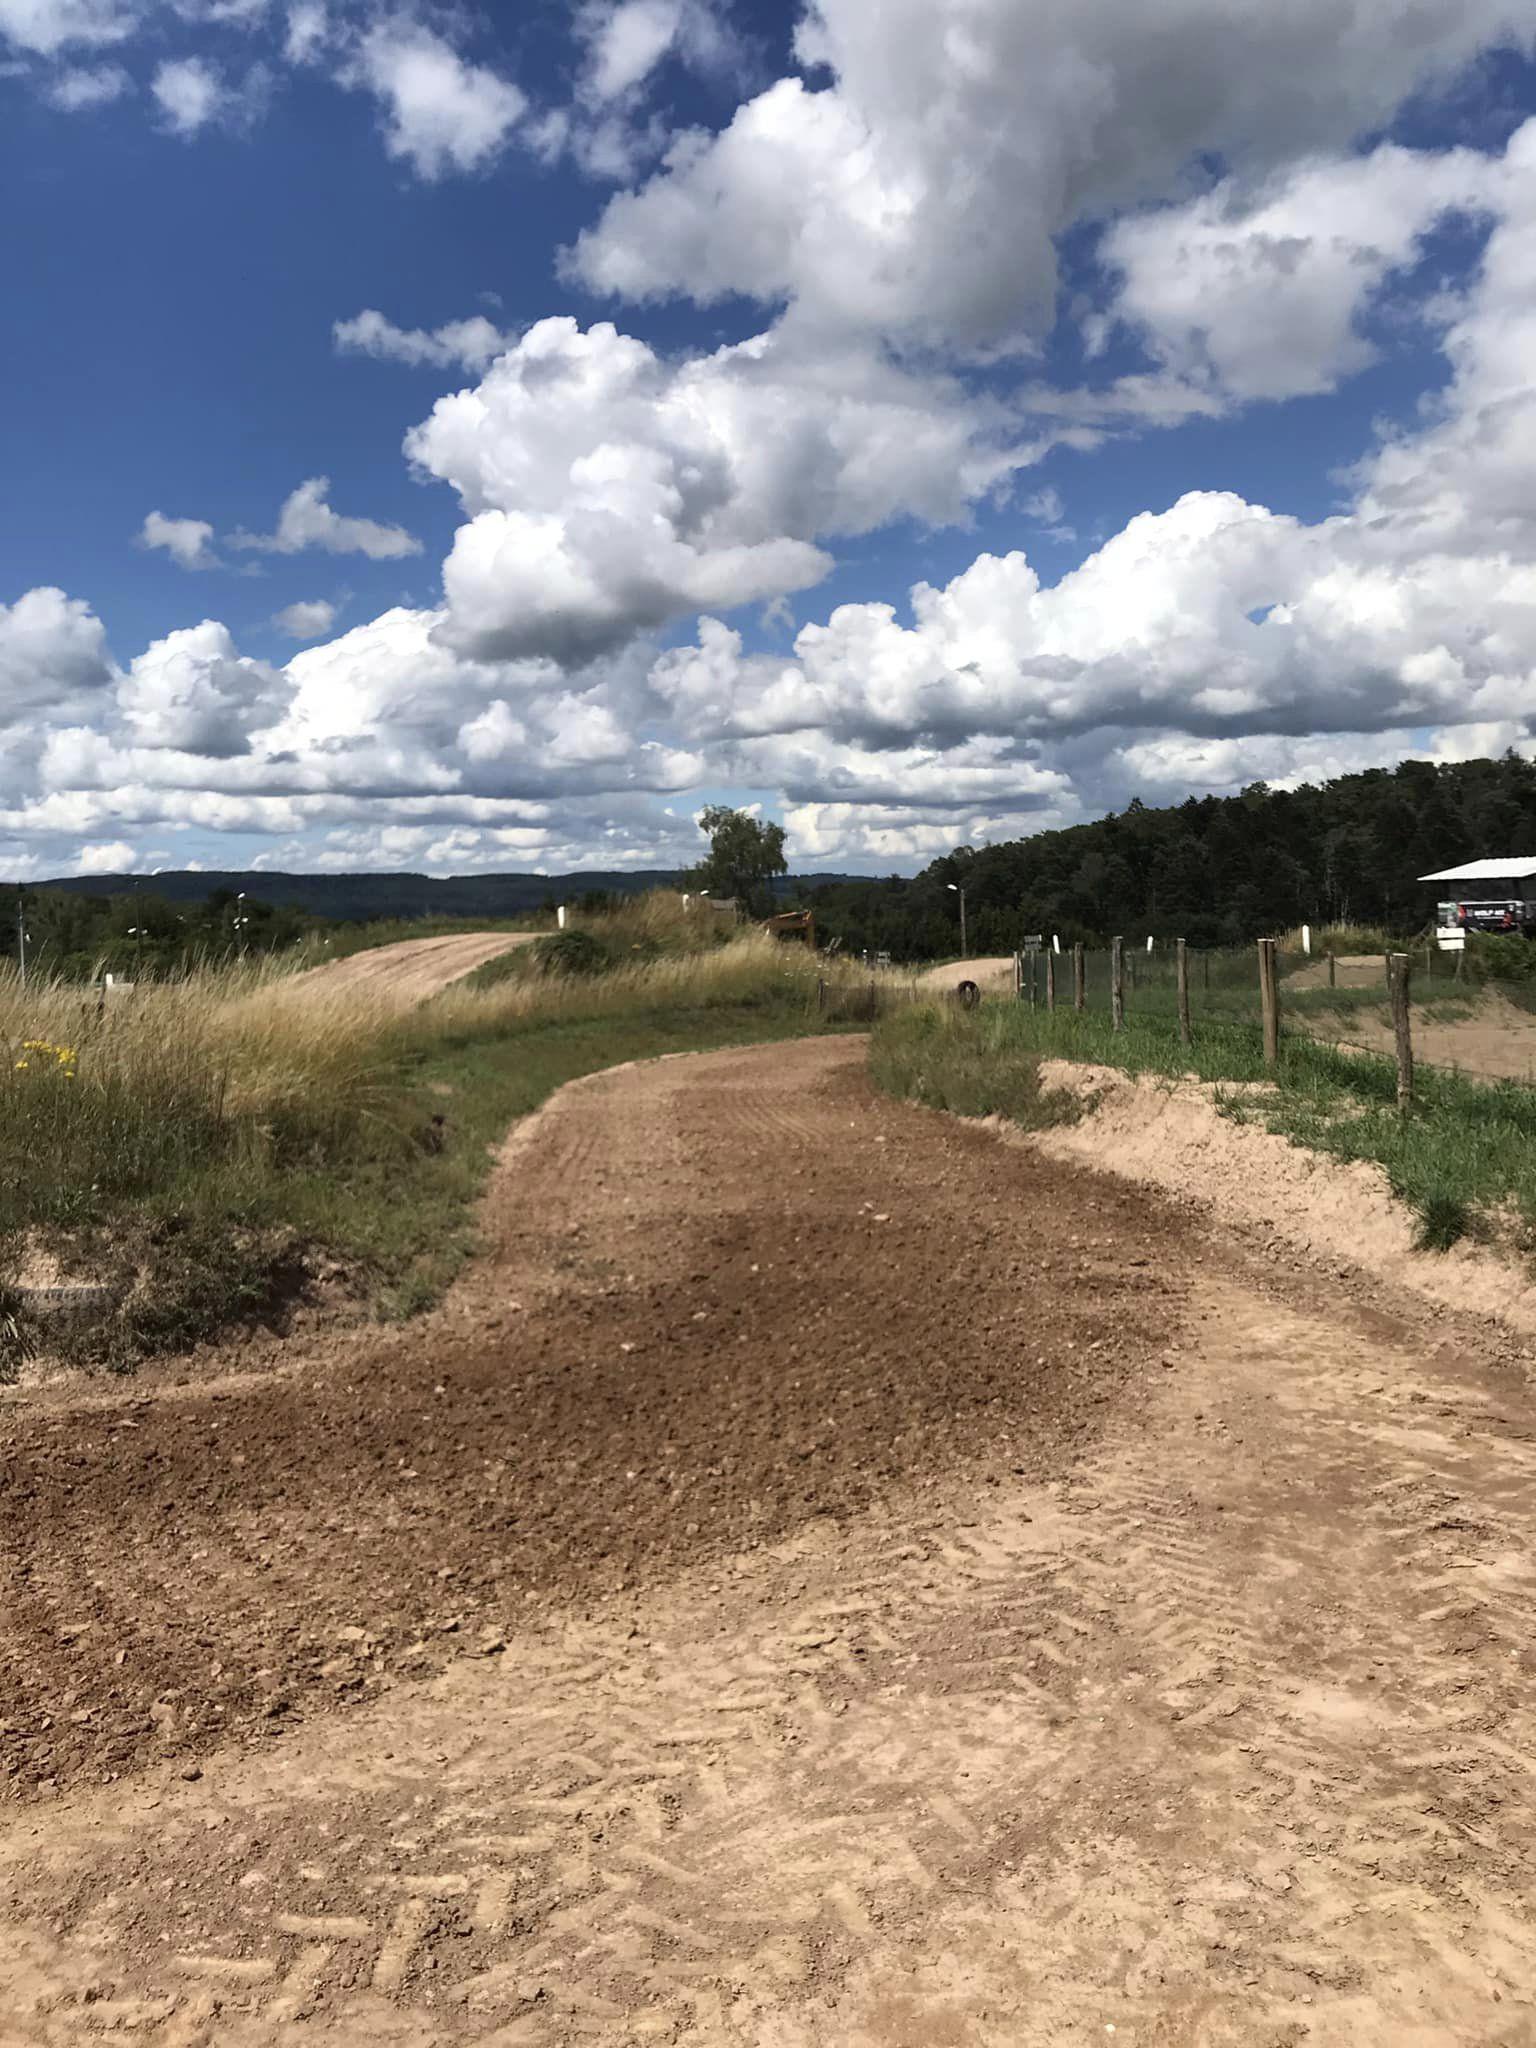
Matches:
[0,1038,1536,2048]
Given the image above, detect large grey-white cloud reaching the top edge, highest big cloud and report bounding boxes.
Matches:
[571,0,1532,348]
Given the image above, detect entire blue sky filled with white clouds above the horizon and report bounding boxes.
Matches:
[0,0,1536,877]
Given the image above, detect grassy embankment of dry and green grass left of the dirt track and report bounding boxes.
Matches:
[0,899,868,1368]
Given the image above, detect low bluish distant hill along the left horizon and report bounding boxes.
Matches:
[31,868,868,924]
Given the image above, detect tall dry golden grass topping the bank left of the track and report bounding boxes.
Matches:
[0,897,876,1237]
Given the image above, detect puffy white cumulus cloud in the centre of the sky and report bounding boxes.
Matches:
[406,319,1022,662]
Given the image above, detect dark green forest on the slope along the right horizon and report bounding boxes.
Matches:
[805,754,1536,961]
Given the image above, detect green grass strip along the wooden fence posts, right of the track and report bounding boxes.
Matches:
[870,942,1536,1249]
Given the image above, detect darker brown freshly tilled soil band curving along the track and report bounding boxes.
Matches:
[0,1040,1194,1792]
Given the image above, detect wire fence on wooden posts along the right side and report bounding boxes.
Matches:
[1004,942,1536,1087]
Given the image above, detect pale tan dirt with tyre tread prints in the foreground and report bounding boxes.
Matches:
[0,1053,1536,2048]
